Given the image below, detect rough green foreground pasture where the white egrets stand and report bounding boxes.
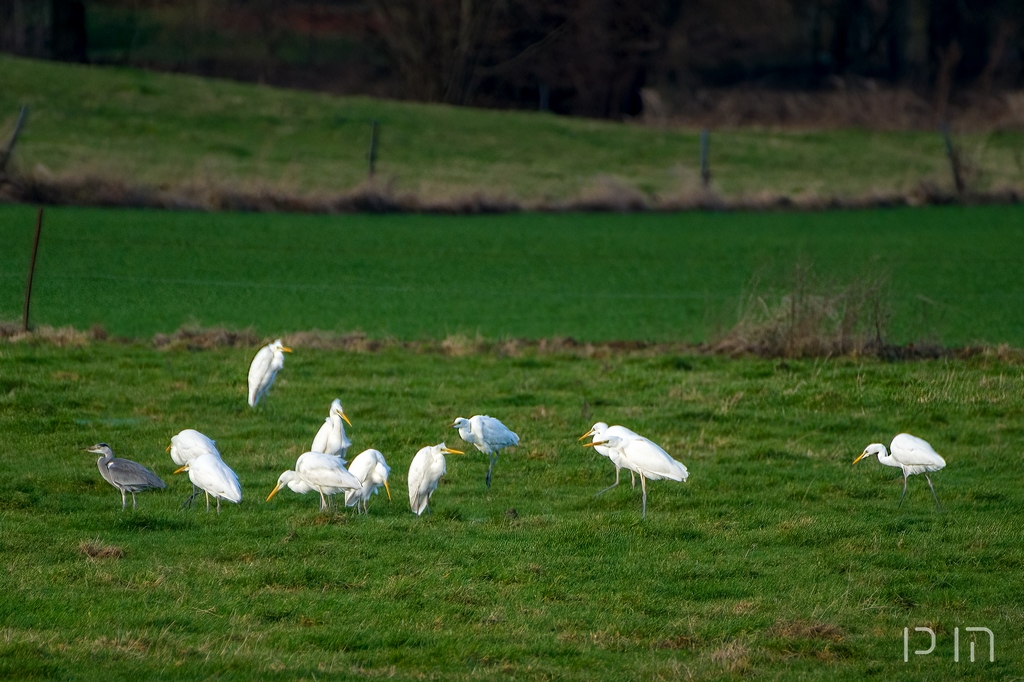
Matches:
[0,343,1024,680]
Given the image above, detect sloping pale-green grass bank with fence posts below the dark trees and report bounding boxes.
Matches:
[0,55,1024,201]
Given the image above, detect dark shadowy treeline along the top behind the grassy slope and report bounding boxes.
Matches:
[0,0,1024,118]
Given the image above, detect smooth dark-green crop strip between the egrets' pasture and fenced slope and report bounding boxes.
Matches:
[0,200,1024,347]
